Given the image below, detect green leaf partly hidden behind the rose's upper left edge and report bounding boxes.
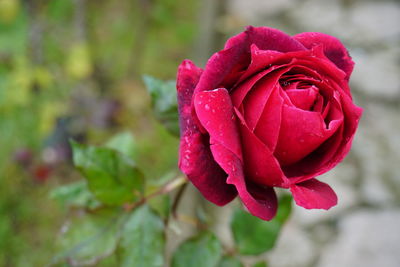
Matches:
[143,75,179,136]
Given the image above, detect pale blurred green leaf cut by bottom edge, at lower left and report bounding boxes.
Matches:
[54,210,123,266]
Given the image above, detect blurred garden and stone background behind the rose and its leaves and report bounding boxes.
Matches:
[0,0,400,267]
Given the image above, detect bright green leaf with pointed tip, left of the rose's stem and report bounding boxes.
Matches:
[71,141,144,205]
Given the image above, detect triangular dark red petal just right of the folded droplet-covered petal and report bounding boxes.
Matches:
[235,109,288,187]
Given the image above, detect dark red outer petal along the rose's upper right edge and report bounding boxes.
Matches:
[293,32,354,80]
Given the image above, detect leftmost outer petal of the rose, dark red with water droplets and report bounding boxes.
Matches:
[177,60,237,205]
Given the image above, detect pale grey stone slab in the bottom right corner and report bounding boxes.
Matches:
[317,210,400,267]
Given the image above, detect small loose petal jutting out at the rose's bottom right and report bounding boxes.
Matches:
[290,179,337,210]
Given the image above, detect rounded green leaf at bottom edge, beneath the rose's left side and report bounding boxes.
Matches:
[172,232,221,267]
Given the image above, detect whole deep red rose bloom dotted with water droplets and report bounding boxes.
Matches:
[177,26,362,220]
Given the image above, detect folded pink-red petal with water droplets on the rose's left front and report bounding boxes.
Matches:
[194,88,242,159]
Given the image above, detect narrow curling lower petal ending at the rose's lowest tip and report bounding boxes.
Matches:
[211,144,277,221]
